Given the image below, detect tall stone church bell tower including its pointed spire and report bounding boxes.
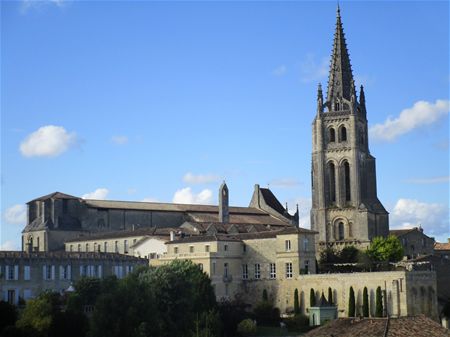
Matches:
[311,7,389,251]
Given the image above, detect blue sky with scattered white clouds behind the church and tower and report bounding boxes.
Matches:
[0,1,450,249]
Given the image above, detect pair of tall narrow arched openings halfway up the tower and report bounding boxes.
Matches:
[327,160,352,204]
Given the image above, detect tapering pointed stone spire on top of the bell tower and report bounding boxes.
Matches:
[327,4,353,111]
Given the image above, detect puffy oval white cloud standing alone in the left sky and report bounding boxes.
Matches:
[20,125,76,157]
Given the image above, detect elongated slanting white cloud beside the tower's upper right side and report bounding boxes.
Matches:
[369,99,450,141]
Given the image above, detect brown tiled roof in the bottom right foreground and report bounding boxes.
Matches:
[305,315,450,337]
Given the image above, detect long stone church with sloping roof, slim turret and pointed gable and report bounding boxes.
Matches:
[22,184,298,252]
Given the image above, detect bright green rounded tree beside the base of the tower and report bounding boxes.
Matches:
[367,235,403,262]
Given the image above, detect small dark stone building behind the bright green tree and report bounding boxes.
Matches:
[389,227,435,259]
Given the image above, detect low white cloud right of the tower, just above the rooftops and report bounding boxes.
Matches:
[390,199,450,240]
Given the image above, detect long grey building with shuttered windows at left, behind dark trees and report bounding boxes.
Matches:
[0,251,148,305]
